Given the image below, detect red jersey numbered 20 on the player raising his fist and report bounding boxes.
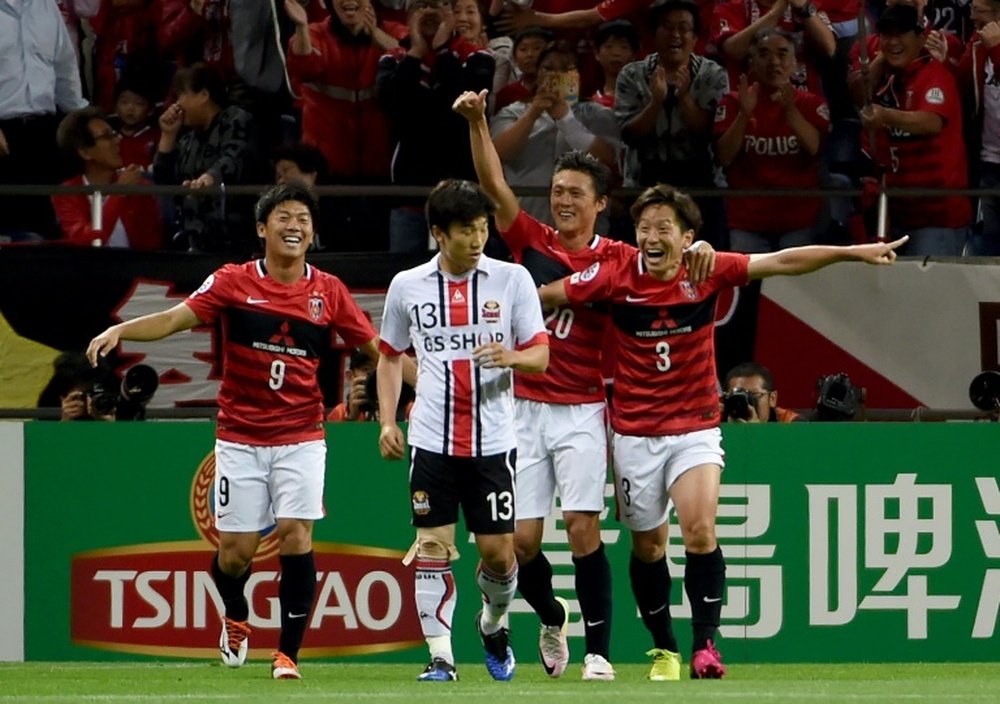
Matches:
[501,210,631,404]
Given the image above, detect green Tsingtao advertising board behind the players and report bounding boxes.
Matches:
[24,423,1000,666]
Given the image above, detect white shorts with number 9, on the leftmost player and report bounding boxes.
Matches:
[215,440,326,533]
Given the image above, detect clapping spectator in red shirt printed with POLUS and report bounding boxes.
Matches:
[715,27,830,253]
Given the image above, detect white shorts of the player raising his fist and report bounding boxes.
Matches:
[514,399,608,520]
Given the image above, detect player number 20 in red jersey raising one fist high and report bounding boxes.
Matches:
[454,91,714,680]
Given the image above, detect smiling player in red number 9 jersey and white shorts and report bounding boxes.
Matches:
[87,183,378,679]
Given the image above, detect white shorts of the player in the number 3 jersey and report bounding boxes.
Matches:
[612,428,725,531]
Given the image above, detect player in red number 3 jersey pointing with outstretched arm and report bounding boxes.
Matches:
[540,184,905,680]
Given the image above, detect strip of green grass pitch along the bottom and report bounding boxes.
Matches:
[0,661,1000,704]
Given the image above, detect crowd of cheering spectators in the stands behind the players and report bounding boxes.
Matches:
[0,0,1000,258]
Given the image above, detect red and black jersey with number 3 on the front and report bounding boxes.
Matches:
[565,250,750,437]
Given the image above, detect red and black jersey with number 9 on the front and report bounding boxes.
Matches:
[185,260,376,445]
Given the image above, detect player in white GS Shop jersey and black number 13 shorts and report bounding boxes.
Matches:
[378,180,549,681]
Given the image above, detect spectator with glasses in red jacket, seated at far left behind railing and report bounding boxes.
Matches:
[52,107,163,250]
